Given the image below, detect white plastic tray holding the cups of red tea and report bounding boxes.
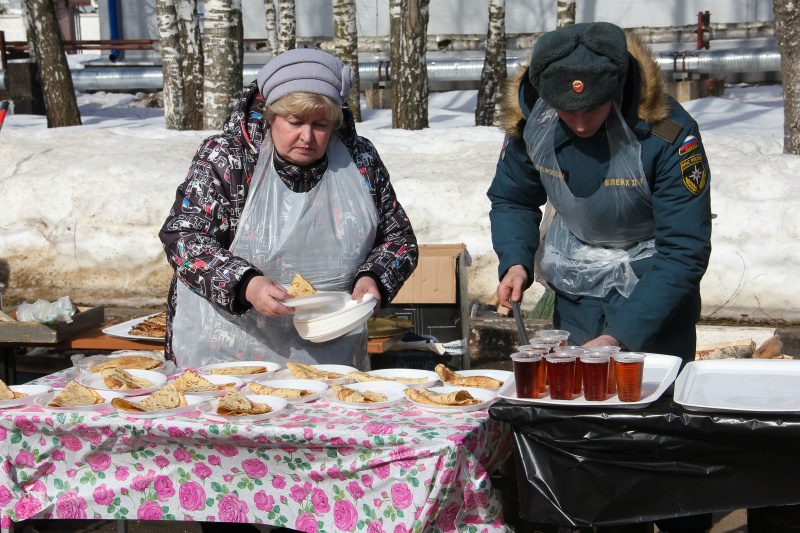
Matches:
[497,353,681,409]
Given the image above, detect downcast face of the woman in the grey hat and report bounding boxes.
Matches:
[270,110,333,167]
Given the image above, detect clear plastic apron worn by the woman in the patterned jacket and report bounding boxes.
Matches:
[172,133,378,370]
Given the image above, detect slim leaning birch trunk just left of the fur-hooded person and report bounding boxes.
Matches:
[475,0,507,126]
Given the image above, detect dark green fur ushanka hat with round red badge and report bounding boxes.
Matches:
[528,22,628,111]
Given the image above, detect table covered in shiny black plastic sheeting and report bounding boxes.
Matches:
[489,388,800,527]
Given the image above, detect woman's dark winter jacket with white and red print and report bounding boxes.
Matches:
[159,82,418,358]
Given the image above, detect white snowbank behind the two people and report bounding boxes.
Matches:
[0,54,800,321]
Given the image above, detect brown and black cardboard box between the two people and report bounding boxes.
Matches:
[379,244,470,369]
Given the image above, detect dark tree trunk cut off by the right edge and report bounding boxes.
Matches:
[773,0,800,155]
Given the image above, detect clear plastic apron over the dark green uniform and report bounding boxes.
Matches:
[524,98,655,298]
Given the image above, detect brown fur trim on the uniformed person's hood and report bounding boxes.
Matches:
[497,32,671,137]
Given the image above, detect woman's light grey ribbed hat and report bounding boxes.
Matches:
[258,48,356,106]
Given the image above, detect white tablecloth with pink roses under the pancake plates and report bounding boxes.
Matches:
[0,371,512,533]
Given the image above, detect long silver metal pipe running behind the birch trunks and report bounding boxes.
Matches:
[0,48,781,91]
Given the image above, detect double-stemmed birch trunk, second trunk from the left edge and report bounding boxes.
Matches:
[156,0,203,130]
